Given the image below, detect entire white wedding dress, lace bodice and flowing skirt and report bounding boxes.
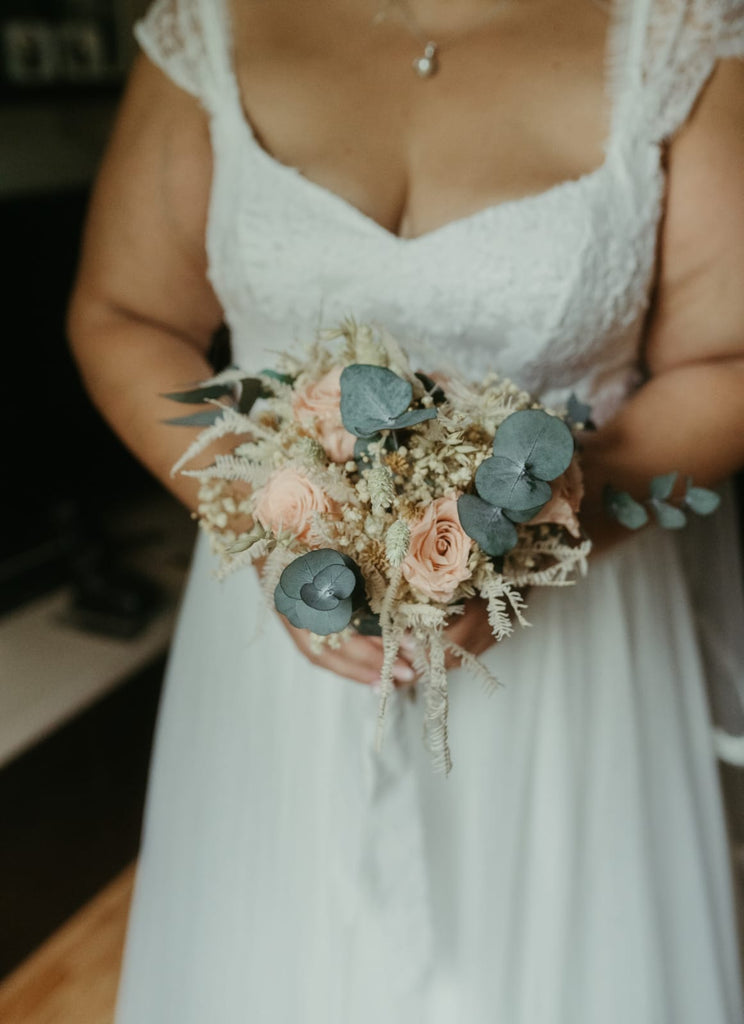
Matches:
[117,0,744,1024]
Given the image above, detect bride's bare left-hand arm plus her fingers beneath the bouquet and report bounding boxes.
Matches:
[69,51,412,683]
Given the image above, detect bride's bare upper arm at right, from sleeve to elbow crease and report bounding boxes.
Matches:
[647,58,744,373]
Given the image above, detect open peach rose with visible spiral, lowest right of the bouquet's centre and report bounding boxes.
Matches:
[402,498,473,601]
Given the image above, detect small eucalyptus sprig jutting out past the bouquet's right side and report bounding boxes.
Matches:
[603,470,720,529]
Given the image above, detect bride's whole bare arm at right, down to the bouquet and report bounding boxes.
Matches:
[584,60,744,551]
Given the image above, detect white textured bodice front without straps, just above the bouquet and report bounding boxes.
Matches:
[209,117,663,407]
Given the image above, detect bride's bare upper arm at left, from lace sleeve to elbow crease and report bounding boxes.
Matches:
[71,56,221,347]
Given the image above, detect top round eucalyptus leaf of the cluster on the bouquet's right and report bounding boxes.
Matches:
[493,409,573,481]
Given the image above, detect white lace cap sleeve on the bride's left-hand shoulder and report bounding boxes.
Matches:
[134,0,224,111]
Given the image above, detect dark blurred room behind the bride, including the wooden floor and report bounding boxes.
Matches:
[0,0,744,1024]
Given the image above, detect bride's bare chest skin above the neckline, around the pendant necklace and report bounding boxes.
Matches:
[231,0,610,238]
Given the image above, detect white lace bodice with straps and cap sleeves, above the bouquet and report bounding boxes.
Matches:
[136,0,744,419]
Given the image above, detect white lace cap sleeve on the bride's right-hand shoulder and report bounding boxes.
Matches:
[643,0,744,140]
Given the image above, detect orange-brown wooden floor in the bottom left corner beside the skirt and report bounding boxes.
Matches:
[0,865,134,1024]
